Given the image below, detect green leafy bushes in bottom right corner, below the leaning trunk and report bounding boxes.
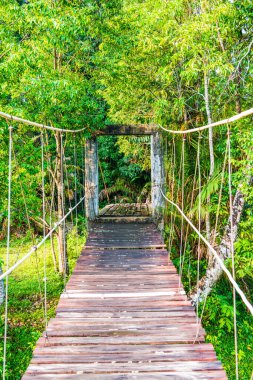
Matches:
[203,286,253,379]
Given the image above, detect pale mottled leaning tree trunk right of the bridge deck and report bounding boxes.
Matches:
[190,190,244,306]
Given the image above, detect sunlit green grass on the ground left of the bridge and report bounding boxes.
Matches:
[0,228,85,380]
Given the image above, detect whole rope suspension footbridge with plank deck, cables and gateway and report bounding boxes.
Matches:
[0,109,253,380]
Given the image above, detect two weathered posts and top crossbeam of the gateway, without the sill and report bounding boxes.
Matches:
[85,125,165,220]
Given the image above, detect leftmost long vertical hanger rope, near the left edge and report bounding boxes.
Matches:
[3,126,13,380]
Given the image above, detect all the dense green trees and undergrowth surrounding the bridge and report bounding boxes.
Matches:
[0,0,253,380]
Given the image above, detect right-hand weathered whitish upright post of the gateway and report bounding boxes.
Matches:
[151,132,165,218]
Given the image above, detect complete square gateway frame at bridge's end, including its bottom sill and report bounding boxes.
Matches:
[85,125,165,220]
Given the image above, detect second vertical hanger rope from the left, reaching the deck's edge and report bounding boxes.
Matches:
[41,131,48,339]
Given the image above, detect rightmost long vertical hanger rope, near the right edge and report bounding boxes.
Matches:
[227,125,239,380]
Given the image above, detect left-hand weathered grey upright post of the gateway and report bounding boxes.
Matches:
[85,138,98,220]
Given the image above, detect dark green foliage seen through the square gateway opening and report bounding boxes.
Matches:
[99,136,150,204]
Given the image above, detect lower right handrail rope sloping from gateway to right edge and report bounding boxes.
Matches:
[159,188,253,316]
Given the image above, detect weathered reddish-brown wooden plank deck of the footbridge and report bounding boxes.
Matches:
[23,223,227,380]
